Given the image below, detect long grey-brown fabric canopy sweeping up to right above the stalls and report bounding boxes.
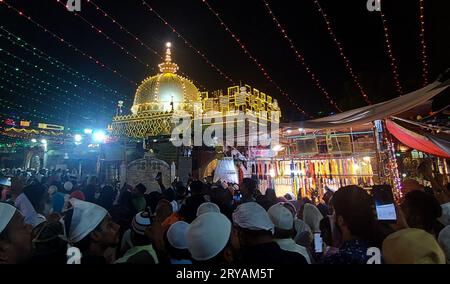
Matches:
[282,74,450,129]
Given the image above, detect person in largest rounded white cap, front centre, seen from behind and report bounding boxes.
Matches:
[186,212,233,265]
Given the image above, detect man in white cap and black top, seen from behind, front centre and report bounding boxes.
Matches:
[232,202,308,265]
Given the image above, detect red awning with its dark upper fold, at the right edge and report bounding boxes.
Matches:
[386,119,450,159]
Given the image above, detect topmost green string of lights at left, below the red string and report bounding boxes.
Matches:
[0,26,124,101]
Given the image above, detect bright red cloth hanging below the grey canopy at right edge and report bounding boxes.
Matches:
[386,120,450,159]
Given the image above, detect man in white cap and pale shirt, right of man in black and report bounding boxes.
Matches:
[267,203,311,264]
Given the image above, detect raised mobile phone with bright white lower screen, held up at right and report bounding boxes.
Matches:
[372,185,397,222]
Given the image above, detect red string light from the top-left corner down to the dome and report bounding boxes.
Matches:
[0,0,137,86]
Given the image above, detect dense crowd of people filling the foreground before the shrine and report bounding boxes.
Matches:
[0,165,450,266]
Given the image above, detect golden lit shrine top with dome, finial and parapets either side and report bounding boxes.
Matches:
[112,43,280,138]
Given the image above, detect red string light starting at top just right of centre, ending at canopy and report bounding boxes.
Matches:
[262,0,342,112]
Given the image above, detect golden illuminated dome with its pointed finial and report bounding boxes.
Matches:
[131,43,201,114]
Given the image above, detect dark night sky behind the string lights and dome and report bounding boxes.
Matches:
[0,0,450,128]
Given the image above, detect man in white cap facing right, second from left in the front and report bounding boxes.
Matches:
[64,198,120,264]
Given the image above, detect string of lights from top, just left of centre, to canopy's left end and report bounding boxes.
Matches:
[202,0,311,117]
